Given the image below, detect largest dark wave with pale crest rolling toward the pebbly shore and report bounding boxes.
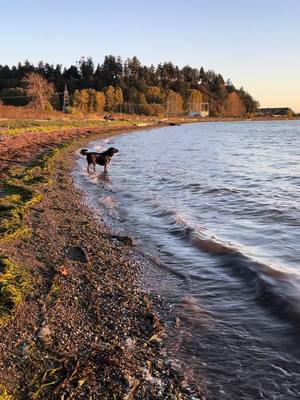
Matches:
[161,209,300,328]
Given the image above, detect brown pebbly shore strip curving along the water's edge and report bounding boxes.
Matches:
[0,125,204,399]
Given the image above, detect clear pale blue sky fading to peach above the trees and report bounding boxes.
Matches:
[0,0,300,112]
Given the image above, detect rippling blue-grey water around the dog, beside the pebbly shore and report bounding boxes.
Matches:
[76,121,300,400]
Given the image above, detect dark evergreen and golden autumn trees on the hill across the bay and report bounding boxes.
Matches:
[0,55,259,116]
